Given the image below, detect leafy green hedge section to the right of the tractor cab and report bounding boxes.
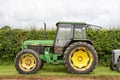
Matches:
[88,29,120,66]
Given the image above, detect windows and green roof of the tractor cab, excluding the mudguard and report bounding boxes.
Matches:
[55,22,87,46]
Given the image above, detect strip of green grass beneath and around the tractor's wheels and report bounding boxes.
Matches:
[0,64,120,77]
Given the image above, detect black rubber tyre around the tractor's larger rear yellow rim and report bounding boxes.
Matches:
[64,42,98,74]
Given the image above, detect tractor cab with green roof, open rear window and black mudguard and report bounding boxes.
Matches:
[54,22,98,54]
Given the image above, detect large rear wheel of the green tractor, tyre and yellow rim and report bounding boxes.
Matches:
[64,42,98,74]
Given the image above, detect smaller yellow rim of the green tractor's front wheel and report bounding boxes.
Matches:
[19,53,36,71]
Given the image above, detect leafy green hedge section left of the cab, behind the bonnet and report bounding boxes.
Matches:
[0,27,55,64]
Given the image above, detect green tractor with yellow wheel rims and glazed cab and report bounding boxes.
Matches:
[15,22,98,74]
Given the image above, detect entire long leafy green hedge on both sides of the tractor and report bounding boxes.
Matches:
[0,26,120,66]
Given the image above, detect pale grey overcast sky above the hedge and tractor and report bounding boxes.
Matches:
[0,0,120,28]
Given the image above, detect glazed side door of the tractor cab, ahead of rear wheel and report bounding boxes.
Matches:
[54,24,74,54]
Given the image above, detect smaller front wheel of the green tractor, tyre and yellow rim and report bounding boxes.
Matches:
[15,49,42,74]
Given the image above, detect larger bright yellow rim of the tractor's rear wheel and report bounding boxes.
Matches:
[69,47,93,71]
